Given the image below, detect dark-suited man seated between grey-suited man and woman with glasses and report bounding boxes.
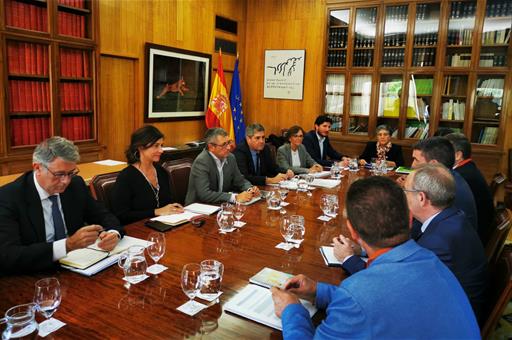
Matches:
[234,123,294,185]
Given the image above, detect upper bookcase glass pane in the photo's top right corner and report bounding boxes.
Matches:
[479,0,512,67]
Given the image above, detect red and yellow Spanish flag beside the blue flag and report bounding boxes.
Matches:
[205,50,235,140]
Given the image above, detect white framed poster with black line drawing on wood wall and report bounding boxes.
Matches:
[263,50,306,100]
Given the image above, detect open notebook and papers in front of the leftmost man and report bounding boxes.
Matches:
[59,236,151,276]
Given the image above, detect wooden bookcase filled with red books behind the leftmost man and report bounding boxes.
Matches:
[0,0,99,171]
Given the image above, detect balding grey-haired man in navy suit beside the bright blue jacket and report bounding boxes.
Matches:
[334,164,487,319]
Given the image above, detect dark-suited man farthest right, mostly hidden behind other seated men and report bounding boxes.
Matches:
[445,133,496,246]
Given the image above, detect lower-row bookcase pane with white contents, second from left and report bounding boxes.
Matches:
[348,75,372,135]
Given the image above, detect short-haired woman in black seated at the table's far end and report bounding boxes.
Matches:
[359,125,404,167]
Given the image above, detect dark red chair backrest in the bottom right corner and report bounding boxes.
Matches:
[481,252,512,339]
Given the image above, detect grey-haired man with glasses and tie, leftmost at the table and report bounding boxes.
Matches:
[0,137,123,274]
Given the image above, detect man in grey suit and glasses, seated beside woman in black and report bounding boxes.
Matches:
[185,128,260,205]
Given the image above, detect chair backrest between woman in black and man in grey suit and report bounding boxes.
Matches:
[162,158,193,204]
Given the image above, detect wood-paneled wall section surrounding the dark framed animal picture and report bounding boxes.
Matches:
[99,0,246,160]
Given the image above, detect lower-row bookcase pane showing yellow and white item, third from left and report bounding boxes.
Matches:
[377,75,402,137]
